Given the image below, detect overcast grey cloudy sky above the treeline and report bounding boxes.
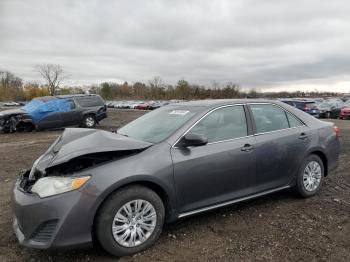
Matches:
[0,0,350,92]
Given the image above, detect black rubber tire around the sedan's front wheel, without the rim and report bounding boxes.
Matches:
[95,186,165,256]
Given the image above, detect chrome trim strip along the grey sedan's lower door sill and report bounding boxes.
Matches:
[178,185,290,218]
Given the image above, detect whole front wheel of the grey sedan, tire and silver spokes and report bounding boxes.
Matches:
[95,185,165,257]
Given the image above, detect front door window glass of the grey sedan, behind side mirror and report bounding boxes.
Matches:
[189,106,248,143]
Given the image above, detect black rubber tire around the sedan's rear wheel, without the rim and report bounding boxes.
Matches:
[296,154,324,197]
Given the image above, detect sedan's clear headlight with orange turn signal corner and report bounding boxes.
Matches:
[32,176,90,197]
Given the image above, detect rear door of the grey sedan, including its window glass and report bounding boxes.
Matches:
[250,103,310,191]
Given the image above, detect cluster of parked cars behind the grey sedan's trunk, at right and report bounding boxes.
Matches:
[280,98,350,119]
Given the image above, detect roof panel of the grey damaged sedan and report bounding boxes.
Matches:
[172,99,279,107]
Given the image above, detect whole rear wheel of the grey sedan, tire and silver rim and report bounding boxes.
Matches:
[295,154,324,198]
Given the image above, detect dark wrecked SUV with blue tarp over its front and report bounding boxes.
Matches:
[0,95,107,133]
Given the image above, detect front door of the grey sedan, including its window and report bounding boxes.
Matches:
[171,105,255,212]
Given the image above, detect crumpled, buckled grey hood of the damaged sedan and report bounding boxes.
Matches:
[44,128,152,168]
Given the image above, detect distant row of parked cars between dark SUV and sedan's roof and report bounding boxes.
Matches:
[106,100,174,110]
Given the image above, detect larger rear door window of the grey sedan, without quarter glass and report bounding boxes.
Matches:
[250,104,289,133]
